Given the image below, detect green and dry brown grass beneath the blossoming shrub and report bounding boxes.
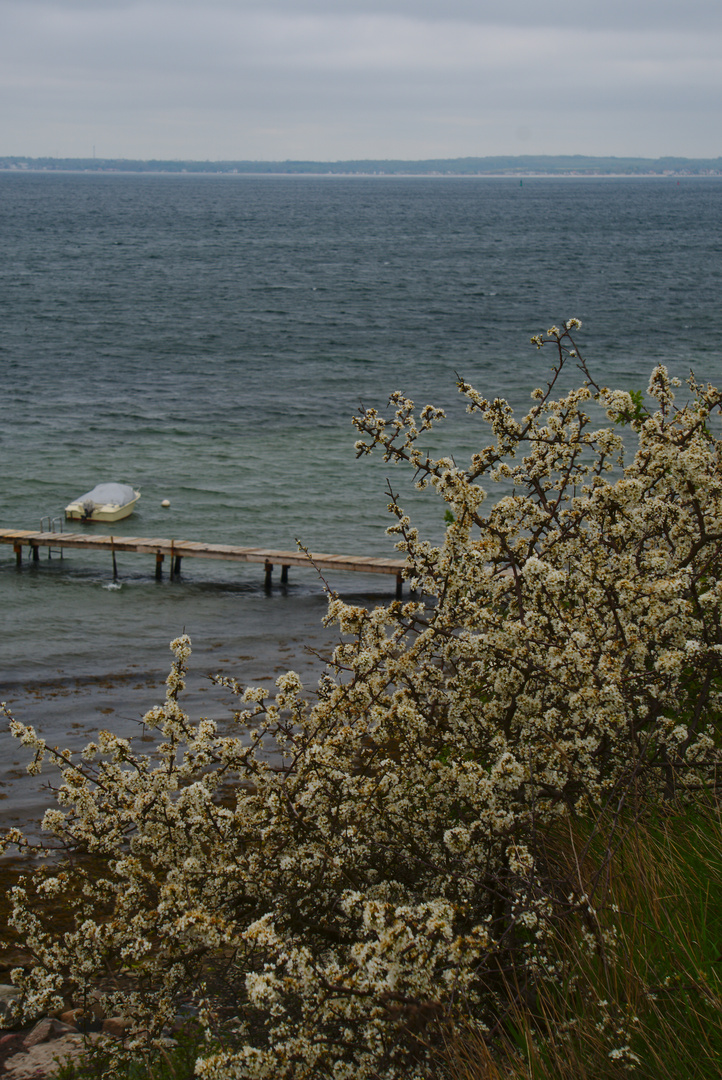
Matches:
[439,805,722,1080]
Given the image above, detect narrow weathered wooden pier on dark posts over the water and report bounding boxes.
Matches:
[0,529,407,596]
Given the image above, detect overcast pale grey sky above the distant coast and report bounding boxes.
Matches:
[0,0,722,161]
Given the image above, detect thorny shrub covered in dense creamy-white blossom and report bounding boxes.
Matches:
[5,320,722,1080]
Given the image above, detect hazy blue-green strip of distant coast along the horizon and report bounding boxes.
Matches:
[0,154,722,179]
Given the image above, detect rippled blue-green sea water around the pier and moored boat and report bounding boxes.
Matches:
[0,174,722,820]
